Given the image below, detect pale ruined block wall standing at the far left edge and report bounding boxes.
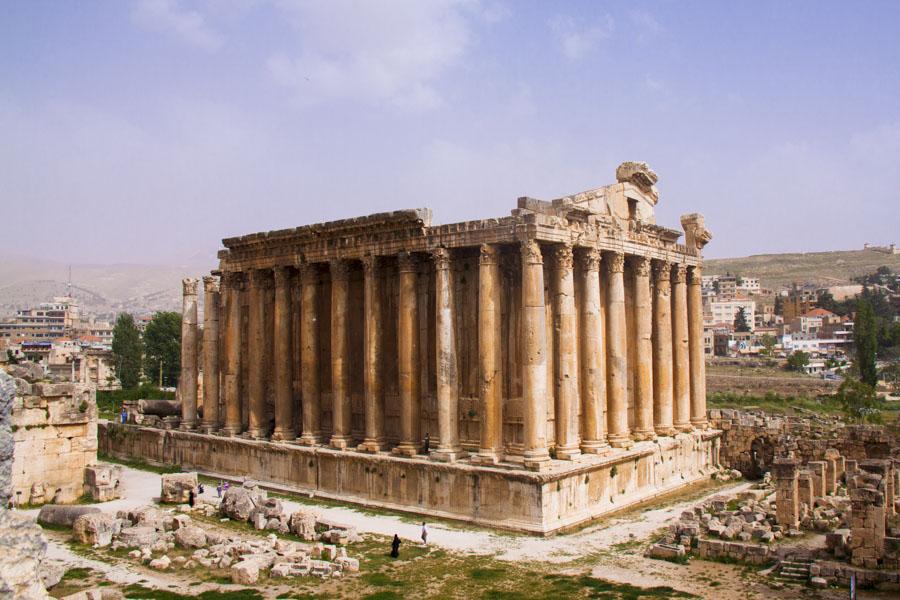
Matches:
[4,364,97,504]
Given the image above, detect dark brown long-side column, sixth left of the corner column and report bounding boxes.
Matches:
[300,263,322,446]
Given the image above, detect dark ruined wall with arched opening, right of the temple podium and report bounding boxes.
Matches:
[709,409,900,478]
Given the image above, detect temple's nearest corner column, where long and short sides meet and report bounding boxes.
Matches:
[522,240,550,470]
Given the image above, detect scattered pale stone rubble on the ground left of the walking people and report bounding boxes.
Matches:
[53,473,359,585]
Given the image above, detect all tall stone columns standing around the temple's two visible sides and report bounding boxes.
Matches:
[182,240,706,467]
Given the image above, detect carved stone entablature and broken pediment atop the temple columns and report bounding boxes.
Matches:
[219,163,711,273]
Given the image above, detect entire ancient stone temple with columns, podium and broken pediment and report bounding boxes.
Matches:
[105,163,719,533]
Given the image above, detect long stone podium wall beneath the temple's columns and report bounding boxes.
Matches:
[99,423,719,535]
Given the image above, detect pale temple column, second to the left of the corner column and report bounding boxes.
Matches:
[432,248,461,462]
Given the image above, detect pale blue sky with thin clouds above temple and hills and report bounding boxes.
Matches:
[0,0,900,262]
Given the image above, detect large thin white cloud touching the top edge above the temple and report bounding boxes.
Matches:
[266,0,477,109]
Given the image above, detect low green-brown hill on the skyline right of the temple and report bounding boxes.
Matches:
[703,250,900,289]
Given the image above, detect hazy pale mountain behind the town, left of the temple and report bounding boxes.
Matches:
[0,259,212,315]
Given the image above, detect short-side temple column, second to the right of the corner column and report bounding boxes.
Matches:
[579,248,609,454]
